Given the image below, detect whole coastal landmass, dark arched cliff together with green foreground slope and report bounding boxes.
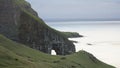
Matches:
[0,0,115,68]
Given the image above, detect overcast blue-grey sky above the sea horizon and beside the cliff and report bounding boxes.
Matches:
[27,0,120,19]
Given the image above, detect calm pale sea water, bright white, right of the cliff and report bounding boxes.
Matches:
[48,21,120,68]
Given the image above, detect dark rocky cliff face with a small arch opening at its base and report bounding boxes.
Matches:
[0,0,75,55]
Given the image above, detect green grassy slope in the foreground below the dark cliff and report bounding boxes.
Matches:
[0,35,114,68]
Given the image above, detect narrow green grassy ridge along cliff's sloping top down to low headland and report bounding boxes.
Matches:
[13,0,77,38]
